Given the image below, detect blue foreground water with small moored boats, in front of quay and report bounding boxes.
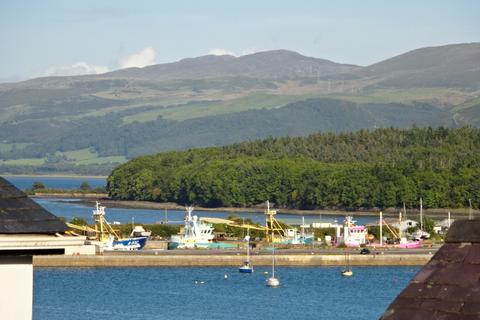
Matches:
[33,267,418,320]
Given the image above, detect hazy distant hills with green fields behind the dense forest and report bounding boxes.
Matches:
[0,43,480,173]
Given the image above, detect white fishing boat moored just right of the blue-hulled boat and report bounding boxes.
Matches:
[168,207,214,249]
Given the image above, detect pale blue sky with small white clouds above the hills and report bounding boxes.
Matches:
[0,0,480,82]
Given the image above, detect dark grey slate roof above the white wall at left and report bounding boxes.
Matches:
[0,177,68,234]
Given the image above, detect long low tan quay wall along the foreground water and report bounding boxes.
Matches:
[33,248,437,267]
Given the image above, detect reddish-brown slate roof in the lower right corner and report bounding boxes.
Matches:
[381,220,480,320]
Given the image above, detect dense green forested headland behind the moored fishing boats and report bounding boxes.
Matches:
[107,127,480,210]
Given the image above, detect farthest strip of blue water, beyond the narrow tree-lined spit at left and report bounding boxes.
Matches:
[3,176,107,190]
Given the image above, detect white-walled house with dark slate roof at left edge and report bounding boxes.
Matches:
[0,177,85,320]
